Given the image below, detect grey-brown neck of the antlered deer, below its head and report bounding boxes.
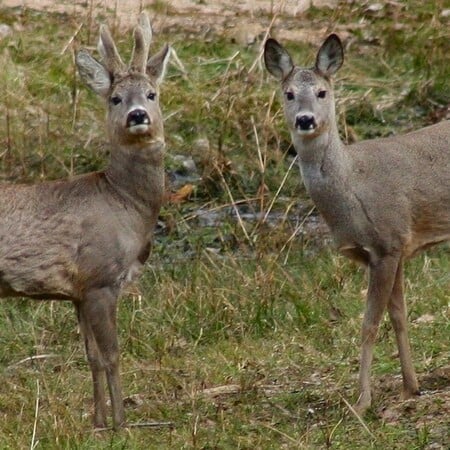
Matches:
[105,141,164,217]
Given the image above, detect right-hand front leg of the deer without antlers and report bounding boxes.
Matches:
[388,261,419,399]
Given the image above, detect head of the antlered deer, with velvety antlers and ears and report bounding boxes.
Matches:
[76,13,170,145]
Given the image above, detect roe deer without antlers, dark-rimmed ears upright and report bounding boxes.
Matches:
[264,34,450,414]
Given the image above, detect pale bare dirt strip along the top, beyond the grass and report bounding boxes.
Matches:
[0,0,337,45]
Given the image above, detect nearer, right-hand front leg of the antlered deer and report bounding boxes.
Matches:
[80,288,125,429]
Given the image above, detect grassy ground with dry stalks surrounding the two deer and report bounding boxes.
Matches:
[0,0,450,449]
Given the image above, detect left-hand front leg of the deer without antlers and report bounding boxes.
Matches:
[355,256,400,414]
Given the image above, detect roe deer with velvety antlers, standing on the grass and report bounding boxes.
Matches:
[0,14,170,429]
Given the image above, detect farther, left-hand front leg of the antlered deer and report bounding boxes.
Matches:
[75,304,107,428]
